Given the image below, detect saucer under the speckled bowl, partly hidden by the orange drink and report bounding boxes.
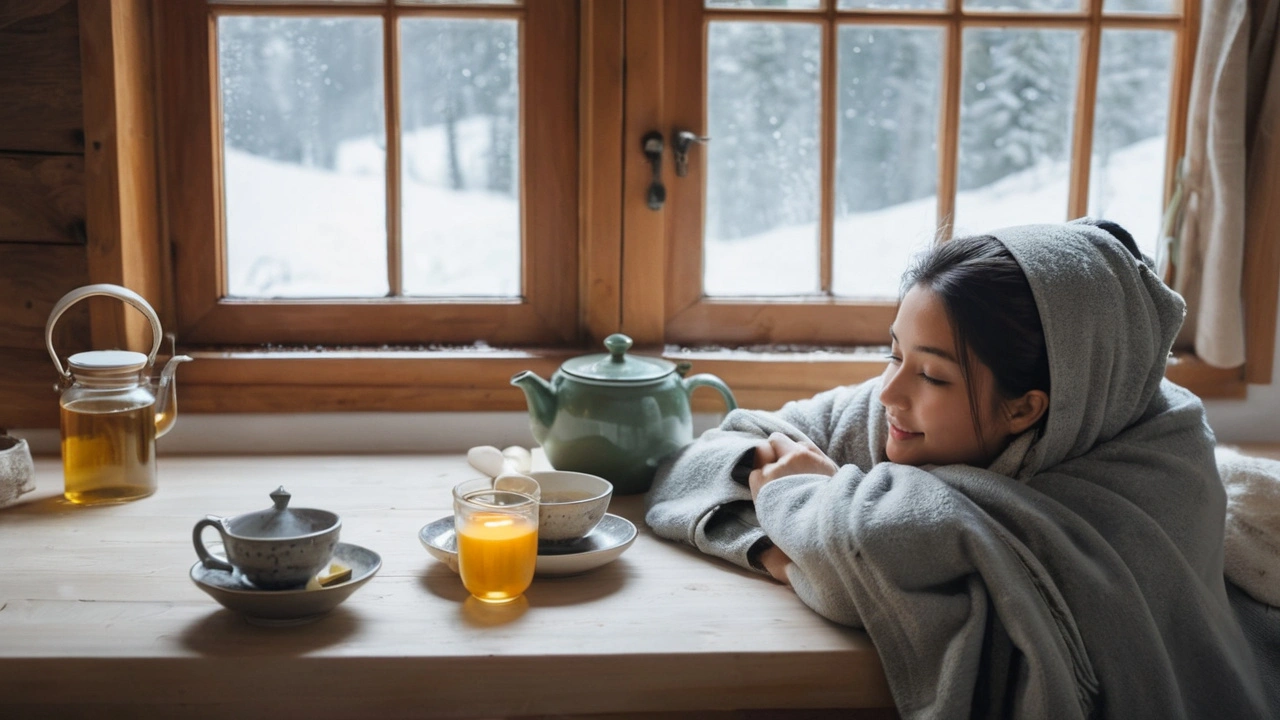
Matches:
[417,512,636,578]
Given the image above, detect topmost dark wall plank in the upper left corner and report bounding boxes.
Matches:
[0,0,84,154]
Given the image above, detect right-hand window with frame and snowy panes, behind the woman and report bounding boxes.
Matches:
[663,0,1192,345]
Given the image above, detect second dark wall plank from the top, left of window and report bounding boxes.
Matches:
[0,149,84,242]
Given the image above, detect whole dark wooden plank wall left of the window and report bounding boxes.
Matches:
[0,0,90,428]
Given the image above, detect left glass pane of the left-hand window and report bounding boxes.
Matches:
[218,15,388,297]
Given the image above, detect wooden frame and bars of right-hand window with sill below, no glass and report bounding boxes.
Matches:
[609,0,1280,409]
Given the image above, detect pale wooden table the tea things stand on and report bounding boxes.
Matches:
[0,455,892,719]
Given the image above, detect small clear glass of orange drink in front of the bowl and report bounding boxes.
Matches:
[453,478,538,603]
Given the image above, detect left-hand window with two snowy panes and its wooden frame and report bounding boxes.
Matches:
[159,0,579,345]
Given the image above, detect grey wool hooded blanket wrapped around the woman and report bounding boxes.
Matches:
[645,222,1280,720]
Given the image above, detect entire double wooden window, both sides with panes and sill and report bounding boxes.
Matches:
[147,0,1244,411]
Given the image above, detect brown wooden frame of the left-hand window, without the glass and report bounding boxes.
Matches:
[156,0,579,346]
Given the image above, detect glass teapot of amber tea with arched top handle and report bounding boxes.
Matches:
[45,283,191,505]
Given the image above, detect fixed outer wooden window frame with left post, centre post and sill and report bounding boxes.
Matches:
[81,0,1280,413]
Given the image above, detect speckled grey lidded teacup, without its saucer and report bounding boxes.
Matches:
[192,487,342,591]
